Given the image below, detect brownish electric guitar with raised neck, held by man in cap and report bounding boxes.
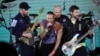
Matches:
[19,7,44,46]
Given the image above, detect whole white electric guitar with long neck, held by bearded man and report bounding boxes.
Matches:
[61,20,97,56]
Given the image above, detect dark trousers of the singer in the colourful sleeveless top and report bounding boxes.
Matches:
[41,43,54,56]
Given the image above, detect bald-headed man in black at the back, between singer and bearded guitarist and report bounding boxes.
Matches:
[54,5,69,44]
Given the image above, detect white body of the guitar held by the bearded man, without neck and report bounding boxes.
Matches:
[62,34,79,56]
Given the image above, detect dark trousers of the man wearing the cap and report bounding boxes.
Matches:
[18,43,34,56]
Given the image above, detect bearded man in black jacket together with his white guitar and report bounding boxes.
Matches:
[62,5,93,56]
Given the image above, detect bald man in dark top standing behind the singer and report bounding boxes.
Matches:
[54,5,69,56]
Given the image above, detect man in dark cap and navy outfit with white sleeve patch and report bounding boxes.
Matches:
[11,2,34,56]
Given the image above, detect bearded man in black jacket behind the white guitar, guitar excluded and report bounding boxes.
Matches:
[61,5,93,56]
